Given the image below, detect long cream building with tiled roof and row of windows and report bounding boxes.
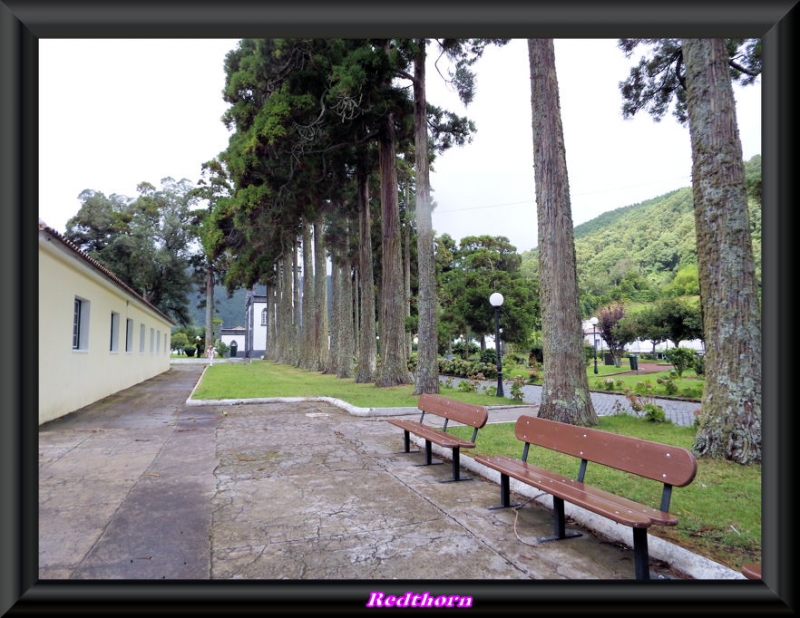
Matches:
[39,220,175,425]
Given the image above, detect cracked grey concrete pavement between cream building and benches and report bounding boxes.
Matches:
[39,365,743,588]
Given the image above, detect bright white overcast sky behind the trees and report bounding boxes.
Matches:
[39,39,761,252]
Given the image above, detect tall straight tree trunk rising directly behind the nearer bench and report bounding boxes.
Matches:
[528,39,598,426]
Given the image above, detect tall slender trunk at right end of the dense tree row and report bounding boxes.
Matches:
[414,39,439,395]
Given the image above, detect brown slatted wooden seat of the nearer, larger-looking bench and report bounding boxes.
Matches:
[475,455,678,528]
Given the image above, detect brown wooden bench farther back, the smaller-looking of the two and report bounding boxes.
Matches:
[389,394,489,483]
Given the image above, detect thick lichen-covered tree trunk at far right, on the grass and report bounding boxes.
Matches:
[683,39,761,464]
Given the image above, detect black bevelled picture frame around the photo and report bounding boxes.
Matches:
[0,0,798,616]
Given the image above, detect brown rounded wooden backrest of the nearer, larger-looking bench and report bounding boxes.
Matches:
[515,415,697,486]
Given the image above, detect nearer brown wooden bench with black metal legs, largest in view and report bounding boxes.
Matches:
[475,415,697,579]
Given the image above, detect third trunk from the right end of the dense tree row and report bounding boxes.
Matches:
[356,174,377,384]
